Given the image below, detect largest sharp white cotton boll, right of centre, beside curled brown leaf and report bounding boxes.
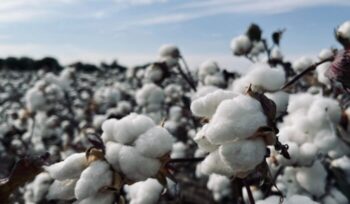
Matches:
[191,91,267,177]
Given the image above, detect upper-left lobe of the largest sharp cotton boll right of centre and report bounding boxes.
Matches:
[191,89,237,118]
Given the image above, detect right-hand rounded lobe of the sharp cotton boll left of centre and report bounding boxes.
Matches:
[135,126,174,158]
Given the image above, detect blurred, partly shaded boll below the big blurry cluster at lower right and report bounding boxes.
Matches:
[296,160,327,197]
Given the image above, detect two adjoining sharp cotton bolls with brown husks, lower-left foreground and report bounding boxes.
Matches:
[45,113,173,203]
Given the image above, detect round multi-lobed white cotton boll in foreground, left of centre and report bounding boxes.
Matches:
[102,113,173,181]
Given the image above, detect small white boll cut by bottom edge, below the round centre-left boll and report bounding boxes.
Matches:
[125,179,163,204]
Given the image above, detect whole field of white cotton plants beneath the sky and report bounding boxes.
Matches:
[0,21,350,204]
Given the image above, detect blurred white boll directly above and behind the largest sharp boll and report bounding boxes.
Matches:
[232,63,286,93]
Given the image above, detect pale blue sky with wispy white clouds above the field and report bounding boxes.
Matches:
[0,0,350,68]
